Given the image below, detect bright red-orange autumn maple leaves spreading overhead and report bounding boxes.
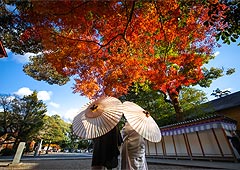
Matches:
[7,0,227,120]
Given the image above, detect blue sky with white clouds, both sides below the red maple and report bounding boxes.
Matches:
[0,44,240,121]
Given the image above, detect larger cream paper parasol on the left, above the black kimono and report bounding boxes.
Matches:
[72,97,123,139]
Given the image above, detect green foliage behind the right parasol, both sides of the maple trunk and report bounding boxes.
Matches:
[120,84,207,126]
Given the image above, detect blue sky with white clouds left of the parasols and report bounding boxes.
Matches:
[0,50,89,121]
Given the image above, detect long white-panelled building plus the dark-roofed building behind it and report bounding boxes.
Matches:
[146,92,240,162]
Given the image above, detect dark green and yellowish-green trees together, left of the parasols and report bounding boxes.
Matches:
[0,91,75,153]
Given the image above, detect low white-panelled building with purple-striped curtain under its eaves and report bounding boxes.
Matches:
[146,115,240,162]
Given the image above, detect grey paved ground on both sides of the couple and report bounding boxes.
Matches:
[0,158,240,170]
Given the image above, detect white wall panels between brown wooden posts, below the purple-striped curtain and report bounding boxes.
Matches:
[146,129,234,159]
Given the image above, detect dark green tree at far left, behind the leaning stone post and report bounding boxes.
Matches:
[0,91,47,152]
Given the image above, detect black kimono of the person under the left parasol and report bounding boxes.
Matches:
[92,126,122,169]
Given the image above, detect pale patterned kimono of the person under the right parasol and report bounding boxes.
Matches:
[121,122,148,170]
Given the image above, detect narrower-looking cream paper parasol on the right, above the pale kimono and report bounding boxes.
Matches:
[123,101,162,142]
